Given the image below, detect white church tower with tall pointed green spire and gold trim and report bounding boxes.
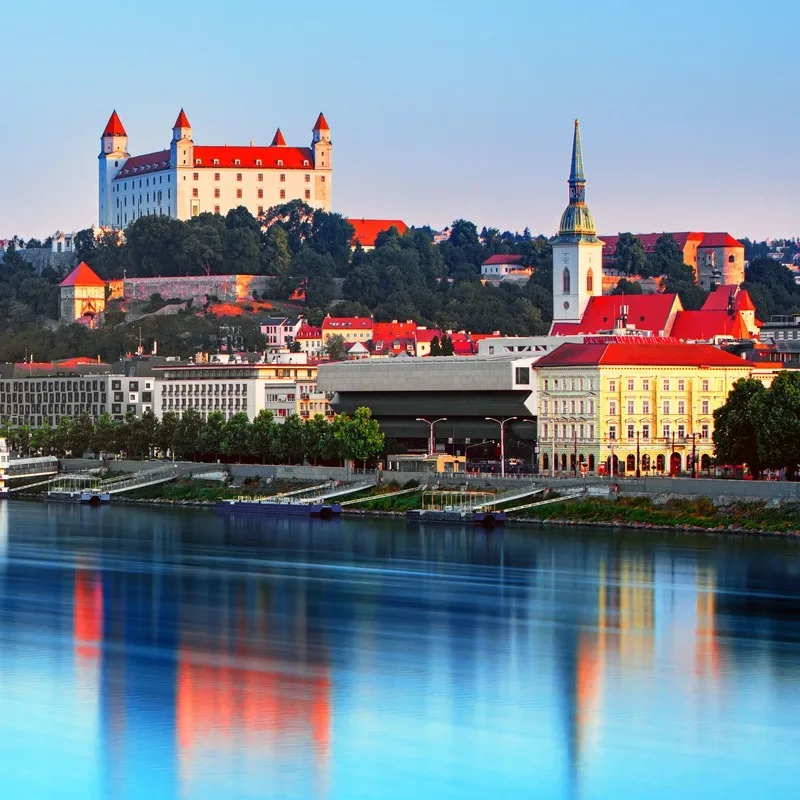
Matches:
[553,119,603,323]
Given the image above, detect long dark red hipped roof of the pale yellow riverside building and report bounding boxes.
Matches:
[536,342,751,369]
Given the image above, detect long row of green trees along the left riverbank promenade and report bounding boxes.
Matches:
[0,408,384,464]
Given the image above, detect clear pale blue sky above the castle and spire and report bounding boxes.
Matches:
[0,0,800,239]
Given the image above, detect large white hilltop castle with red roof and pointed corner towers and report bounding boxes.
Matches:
[98,109,333,228]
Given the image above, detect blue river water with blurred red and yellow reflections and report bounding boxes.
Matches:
[0,501,800,800]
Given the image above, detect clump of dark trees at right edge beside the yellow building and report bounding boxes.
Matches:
[714,370,800,479]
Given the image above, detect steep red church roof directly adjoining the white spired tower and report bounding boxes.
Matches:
[550,294,683,336]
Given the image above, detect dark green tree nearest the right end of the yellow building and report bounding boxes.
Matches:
[712,378,766,478]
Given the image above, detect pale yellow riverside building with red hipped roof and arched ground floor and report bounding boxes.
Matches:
[536,341,764,475]
